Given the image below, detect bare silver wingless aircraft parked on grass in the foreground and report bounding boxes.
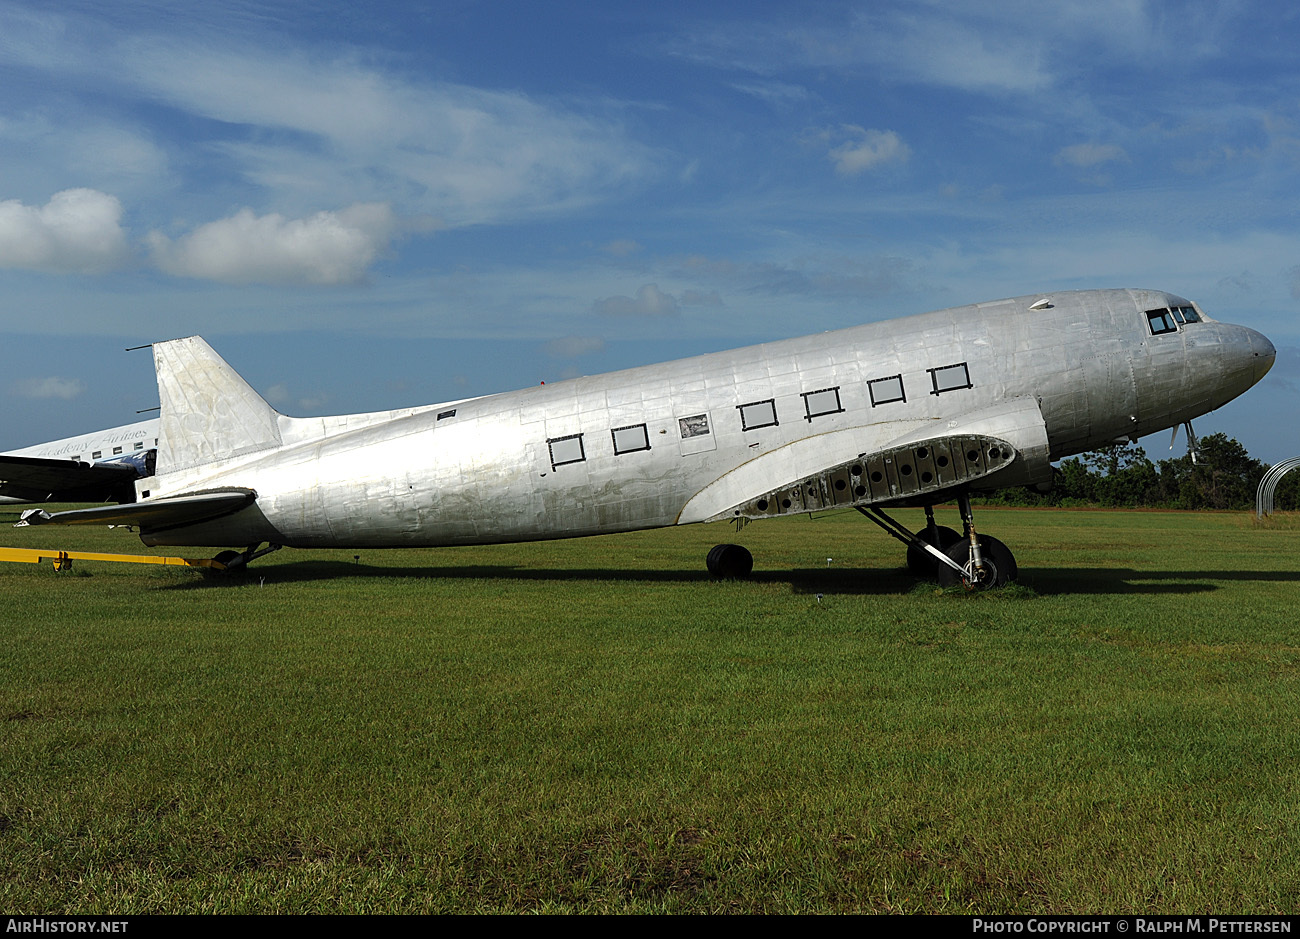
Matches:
[20,290,1275,588]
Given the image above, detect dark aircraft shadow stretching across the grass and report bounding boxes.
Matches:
[169,561,1300,596]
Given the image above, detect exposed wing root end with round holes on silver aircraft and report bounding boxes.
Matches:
[707,434,1018,522]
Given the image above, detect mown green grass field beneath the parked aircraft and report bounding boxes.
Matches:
[0,509,1300,913]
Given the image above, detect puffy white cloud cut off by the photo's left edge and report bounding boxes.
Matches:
[0,189,129,273]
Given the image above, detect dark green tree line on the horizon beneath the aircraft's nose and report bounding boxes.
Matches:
[985,433,1300,511]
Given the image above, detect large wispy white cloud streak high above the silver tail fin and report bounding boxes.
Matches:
[117,40,653,226]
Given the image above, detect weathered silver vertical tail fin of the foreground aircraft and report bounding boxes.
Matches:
[153,336,281,475]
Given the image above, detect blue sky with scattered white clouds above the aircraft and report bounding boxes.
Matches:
[0,0,1300,462]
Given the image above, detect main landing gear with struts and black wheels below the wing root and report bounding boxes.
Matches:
[858,493,1017,590]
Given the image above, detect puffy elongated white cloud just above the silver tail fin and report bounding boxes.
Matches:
[148,203,397,286]
